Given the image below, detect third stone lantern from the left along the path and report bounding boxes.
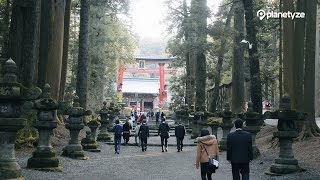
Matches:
[62,96,91,160]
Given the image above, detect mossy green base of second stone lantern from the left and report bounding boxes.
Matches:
[27,148,62,172]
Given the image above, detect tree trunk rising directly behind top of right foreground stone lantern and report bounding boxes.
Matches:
[282,0,294,97]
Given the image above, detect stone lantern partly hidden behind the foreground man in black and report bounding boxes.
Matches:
[239,102,263,158]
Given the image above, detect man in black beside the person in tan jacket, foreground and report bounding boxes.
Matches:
[227,119,253,180]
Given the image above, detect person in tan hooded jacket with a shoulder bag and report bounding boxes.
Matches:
[196,129,219,180]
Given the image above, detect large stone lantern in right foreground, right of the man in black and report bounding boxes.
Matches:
[266,95,305,175]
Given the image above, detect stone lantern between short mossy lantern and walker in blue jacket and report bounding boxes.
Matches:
[98,101,111,141]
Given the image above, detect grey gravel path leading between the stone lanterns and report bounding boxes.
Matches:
[17,143,320,180]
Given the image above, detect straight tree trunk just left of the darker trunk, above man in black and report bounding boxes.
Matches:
[231,1,247,113]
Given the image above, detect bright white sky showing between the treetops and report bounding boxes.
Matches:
[130,0,222,40]
